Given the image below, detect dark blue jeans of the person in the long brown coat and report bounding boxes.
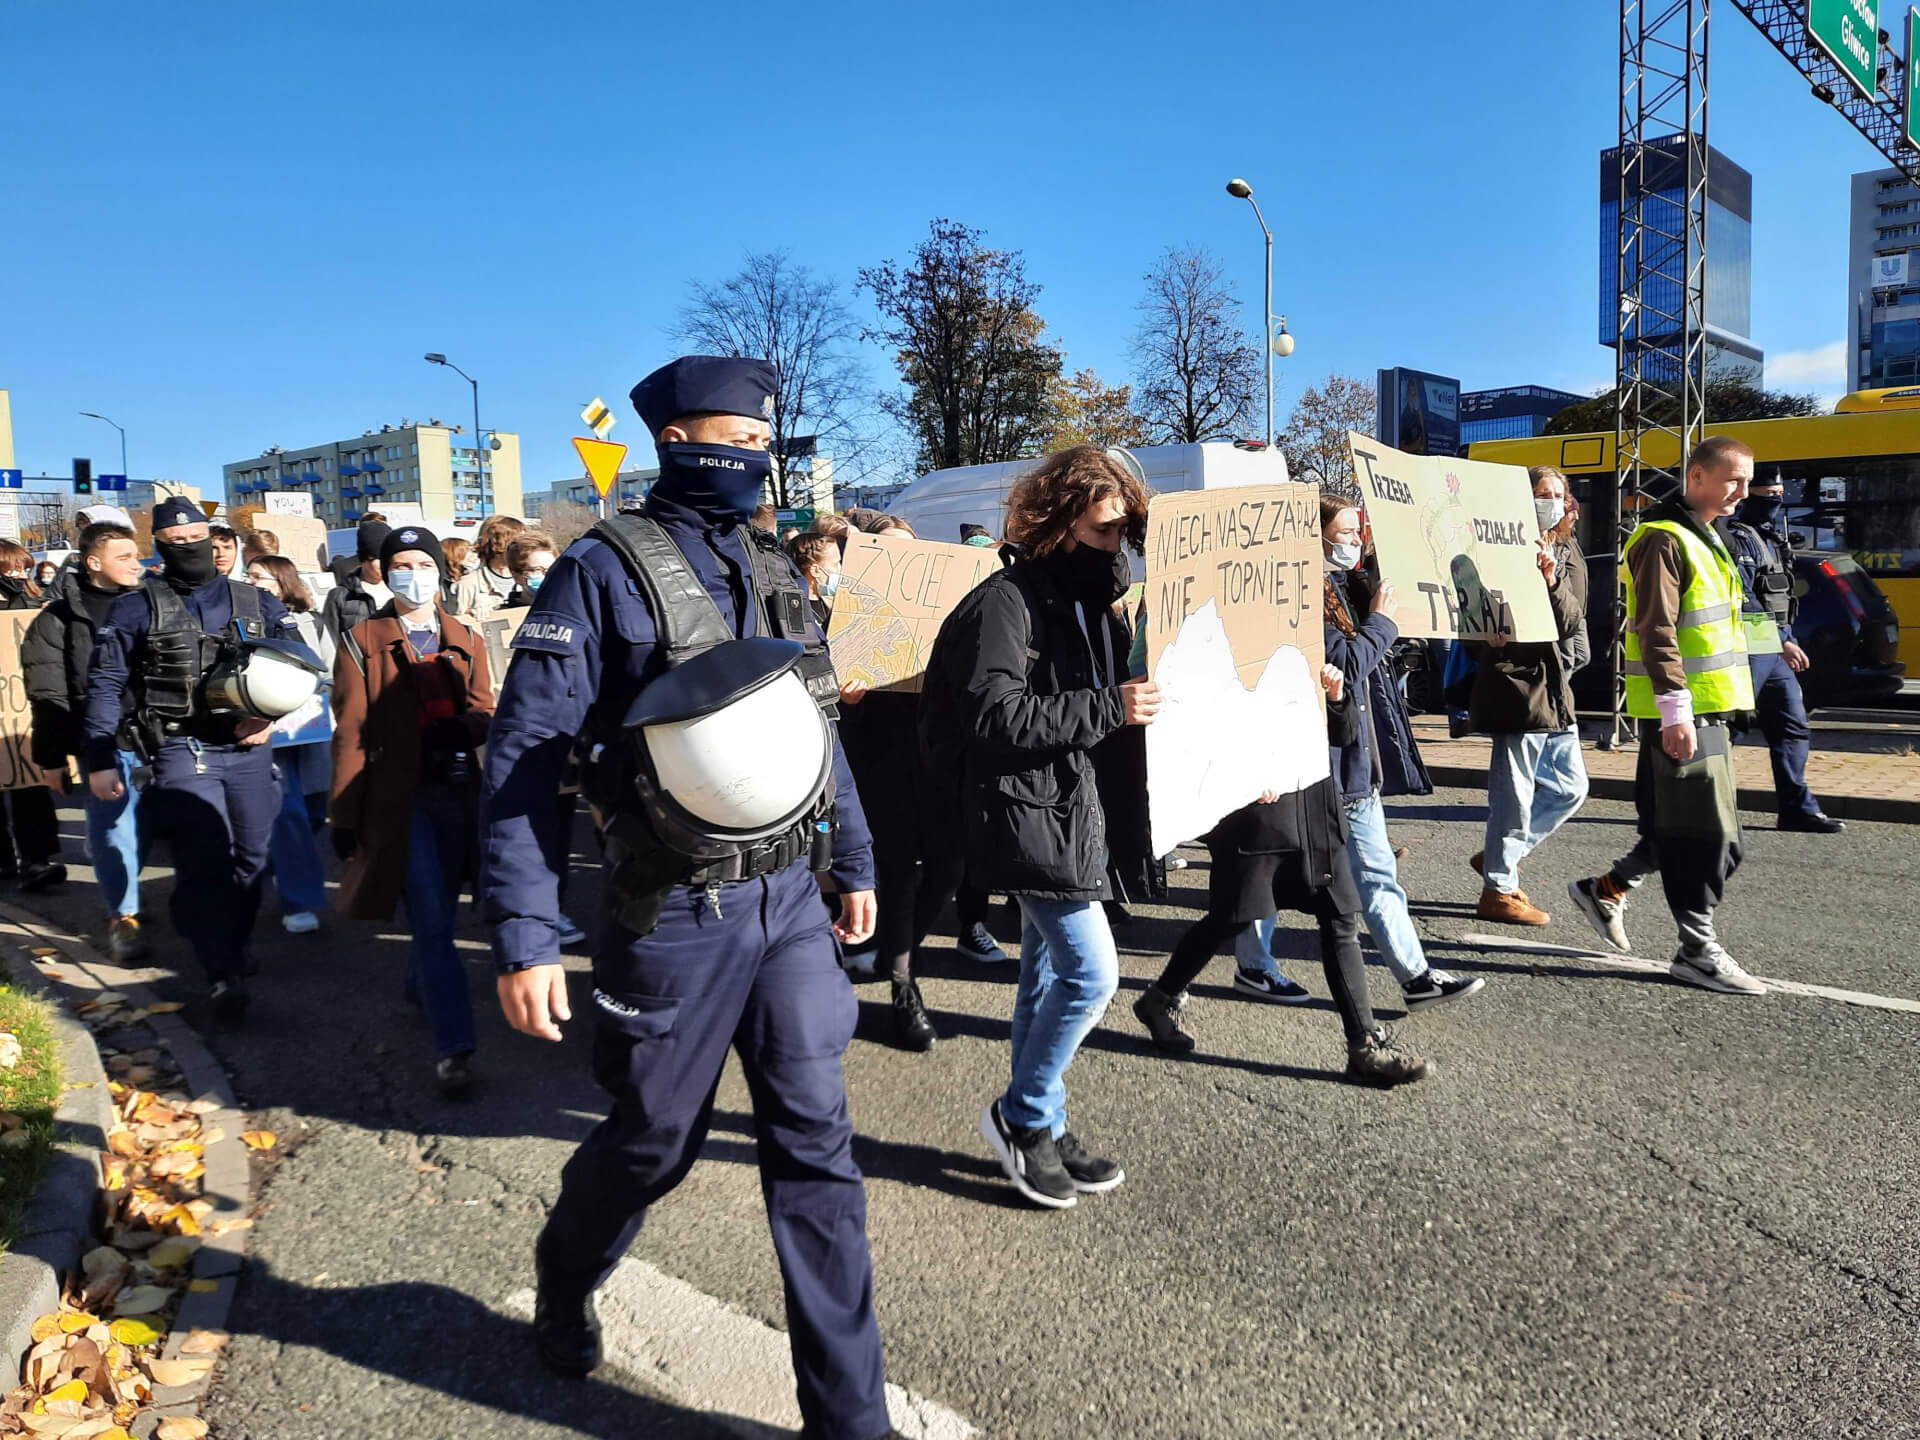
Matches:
[405,789,474,1060]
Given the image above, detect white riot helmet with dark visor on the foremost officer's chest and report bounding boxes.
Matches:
[626,636,833,856]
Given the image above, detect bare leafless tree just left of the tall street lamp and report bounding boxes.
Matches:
[1133,248,1261,444]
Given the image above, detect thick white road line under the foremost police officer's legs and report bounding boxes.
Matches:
[505,1260,979,1440]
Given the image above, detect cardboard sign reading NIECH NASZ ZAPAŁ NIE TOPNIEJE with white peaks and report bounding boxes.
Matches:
[1146,484,1331,854]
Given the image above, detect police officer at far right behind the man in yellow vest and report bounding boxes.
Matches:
[1720,476,1847,835]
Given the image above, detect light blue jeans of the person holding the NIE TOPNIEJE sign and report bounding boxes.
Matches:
[1000,895,1119,1137]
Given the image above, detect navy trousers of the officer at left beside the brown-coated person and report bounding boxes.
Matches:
[142,739,280,983]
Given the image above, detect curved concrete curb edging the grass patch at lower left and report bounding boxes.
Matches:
[0,954,115,1390]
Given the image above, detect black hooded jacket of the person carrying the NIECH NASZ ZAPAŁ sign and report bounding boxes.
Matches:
[920,557,1131,900]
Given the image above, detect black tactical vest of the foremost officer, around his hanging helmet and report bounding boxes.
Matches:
[582,515,839,935]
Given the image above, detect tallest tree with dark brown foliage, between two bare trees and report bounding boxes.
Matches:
[860,219,1062,468]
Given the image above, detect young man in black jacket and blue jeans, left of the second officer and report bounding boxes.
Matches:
[19,524,146,964]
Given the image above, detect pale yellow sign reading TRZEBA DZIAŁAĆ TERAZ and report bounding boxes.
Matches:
[1346,434,1559,643]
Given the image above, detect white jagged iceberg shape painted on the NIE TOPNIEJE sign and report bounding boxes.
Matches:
[1146,601,1331,854]
